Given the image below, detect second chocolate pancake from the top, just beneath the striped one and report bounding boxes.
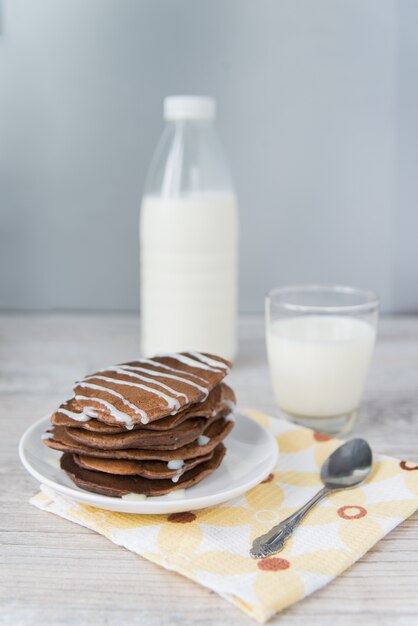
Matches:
[51,383,235,435]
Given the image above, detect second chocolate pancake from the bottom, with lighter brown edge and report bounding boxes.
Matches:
[73,452,213,482]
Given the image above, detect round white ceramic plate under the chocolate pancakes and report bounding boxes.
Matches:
[19,414,278,513]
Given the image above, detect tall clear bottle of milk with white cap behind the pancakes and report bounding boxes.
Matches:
[139,96,238,359]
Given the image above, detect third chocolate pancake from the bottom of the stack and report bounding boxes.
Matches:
[43,419,234,461]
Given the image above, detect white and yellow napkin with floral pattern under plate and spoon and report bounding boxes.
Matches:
[31,411,418,622]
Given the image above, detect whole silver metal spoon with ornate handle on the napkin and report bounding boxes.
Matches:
[250,439,372,559]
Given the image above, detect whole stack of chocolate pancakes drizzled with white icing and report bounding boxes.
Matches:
[44,352,235,497]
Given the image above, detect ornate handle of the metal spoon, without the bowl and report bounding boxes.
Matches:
[250,487,332,559]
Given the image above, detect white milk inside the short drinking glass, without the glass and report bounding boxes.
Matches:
[267,315,375,418]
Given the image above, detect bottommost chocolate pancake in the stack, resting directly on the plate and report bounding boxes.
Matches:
[61,444,225,497]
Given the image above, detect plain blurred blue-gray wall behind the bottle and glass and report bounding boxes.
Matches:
[0,0,418,312]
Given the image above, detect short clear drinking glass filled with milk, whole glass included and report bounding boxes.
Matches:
[266,285,379,434]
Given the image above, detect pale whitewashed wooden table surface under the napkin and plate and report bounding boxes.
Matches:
[0,314,418,626]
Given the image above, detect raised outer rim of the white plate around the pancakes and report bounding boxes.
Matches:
[19,411,279,515]
